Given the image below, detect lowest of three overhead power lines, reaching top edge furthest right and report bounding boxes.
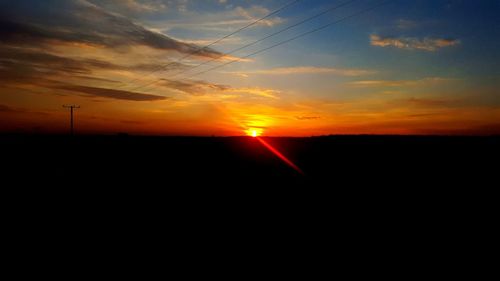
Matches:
[185,0,393,79]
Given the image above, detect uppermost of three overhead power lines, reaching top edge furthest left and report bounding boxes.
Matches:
[124,0,301,91]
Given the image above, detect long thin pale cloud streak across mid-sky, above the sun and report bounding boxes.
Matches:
[231,66,374,76]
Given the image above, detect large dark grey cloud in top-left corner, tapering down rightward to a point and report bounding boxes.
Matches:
[0,0,220,57]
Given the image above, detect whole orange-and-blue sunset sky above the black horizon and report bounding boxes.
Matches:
[0,0,500,136]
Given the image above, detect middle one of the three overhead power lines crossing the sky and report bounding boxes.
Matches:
[133,0,357,91]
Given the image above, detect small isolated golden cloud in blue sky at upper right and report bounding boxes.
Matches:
[370,34,460,52]
